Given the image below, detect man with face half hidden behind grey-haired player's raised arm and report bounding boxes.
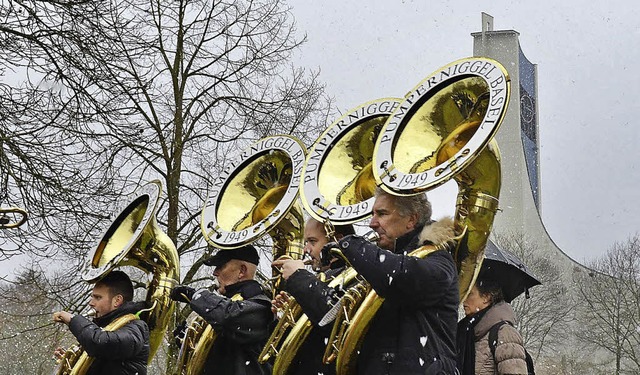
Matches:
[272,219,355,375]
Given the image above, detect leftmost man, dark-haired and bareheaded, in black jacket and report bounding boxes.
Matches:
[53,271,149,375]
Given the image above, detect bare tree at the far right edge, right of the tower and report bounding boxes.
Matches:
[576,235,640,374]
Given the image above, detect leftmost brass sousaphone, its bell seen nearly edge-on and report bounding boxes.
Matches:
[54,180,180,375]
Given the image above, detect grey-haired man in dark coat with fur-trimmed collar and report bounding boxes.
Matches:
[332,188,458,375]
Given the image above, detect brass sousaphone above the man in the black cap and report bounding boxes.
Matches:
[177,135,306,375]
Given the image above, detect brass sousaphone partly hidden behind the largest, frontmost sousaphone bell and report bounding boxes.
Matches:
[268,98,400,374]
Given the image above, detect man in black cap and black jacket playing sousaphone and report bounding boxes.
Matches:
[171,245,273,375]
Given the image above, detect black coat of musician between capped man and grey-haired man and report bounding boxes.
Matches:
[285,265,345,375]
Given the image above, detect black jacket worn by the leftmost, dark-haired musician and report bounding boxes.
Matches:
[69,302,149,375]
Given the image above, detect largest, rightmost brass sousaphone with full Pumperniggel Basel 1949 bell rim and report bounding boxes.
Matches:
[336,57,510,374]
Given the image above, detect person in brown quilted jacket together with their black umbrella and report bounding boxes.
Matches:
[456,242,540,375]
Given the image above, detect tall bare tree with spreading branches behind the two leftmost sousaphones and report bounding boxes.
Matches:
[0,0,330,370]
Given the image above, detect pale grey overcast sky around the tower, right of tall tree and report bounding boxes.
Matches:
[289,0,640,262]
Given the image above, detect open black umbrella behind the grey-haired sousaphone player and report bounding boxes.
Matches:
[480,241,542,302]
